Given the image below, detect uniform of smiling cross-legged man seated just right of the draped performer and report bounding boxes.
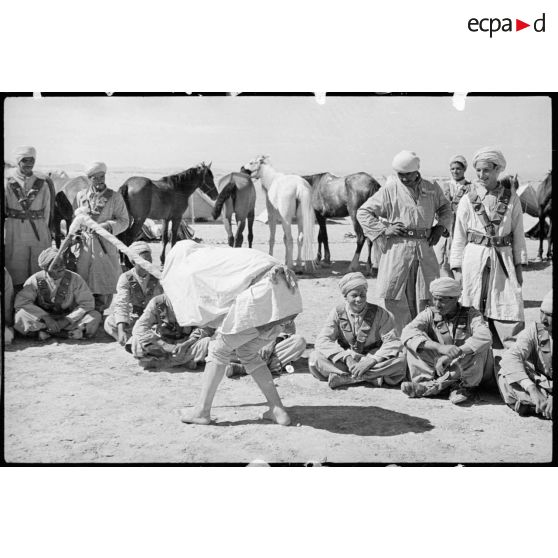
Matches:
[308,302,405,385]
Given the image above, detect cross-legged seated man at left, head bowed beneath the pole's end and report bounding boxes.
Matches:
[14,248,101,341]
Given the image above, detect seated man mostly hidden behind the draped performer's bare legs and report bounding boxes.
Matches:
[225,320,306,378]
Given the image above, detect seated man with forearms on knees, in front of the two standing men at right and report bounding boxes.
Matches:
[401,277,493,405]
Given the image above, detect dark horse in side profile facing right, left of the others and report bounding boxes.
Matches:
[119,163,219,264]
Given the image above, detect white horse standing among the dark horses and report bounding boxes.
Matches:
[243,155,315,273]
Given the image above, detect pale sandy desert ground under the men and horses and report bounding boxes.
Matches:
[4,222,552,464]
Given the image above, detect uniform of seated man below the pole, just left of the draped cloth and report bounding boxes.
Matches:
[105,269,163,339]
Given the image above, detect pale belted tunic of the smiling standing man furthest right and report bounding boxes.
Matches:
[450,184,527,322]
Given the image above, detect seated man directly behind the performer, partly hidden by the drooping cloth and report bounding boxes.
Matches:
[130,294,214,368]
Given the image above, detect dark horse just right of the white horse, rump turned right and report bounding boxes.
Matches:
[303,172,380,273]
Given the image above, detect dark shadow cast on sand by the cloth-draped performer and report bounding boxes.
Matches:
[216,405,434,436]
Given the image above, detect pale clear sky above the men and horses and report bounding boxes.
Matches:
[4,95,551,180]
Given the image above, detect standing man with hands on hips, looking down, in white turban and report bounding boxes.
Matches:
[357,151,453,335]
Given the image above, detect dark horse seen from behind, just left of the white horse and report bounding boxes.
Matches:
[211,169,256,248]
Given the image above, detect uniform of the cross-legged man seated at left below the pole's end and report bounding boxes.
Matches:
[14,270,101,336]
